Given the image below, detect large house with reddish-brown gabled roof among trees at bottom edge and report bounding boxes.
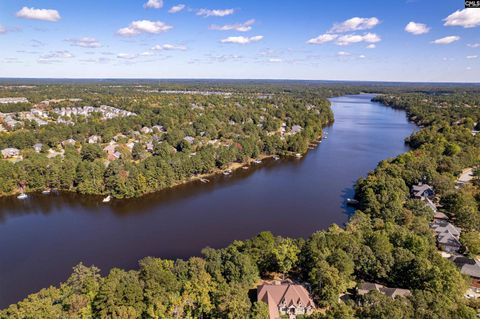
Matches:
[257,281,315,319]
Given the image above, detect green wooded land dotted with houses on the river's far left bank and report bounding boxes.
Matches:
[0,86,333,198]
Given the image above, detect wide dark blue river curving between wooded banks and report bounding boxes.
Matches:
[0,95,416,308]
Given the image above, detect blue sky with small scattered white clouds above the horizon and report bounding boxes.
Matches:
[0,0,480,82]
